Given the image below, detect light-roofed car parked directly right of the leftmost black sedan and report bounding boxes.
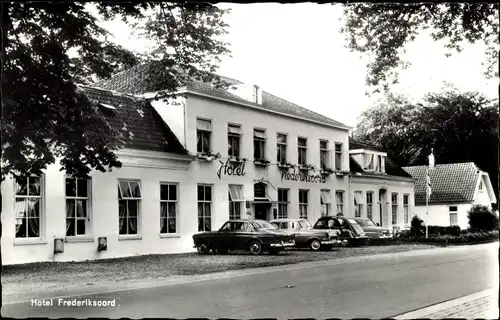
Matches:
[269,219,341,251]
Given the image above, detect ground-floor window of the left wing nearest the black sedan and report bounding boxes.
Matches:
[160,183,178,233]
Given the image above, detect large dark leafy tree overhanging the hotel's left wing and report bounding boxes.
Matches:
[0,2,229,180]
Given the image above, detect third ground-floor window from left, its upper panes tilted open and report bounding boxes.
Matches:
[118,180,142,235]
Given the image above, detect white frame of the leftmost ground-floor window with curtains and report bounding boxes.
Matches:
[12,174,45,240]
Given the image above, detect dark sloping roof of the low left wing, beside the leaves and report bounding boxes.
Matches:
[82,87,187,154]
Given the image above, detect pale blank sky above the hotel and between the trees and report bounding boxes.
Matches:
[102,3,498,127]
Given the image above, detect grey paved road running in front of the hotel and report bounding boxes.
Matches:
[2,244,499,319]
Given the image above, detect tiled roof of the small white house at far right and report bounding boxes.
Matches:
[403,162,479,205]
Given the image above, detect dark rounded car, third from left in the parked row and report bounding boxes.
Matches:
[313,216,368,247]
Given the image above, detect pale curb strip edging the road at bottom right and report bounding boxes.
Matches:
[393,288,498,320]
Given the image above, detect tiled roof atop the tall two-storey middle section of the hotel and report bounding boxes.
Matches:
[93,64,346,128]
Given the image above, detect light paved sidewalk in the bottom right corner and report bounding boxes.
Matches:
[394,289,499,319]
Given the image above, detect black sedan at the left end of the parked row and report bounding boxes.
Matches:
[193,220,295,255]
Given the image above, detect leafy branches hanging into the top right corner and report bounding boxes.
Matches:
[342,2,499,90]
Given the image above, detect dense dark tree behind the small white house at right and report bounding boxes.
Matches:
[353,90,499,210]
